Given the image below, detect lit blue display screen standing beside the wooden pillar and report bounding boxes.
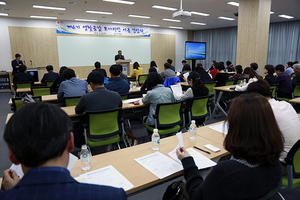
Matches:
[185,41,206,60]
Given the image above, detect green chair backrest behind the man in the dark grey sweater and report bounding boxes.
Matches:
[86,108,122,139]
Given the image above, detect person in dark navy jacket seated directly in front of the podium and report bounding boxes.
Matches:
[105,65,130,95]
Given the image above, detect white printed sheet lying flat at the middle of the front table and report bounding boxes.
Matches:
[134,152,183,179]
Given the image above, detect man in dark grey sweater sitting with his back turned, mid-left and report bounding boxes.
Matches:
[74,71,122,147]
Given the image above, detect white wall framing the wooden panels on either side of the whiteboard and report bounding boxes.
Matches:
[0,17,186,71]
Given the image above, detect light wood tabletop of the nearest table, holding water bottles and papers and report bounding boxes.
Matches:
[70,124,228,194]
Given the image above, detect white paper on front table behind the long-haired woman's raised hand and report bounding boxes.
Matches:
[168,148,217,169]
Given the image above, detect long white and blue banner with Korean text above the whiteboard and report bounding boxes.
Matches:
[56,21,150,37]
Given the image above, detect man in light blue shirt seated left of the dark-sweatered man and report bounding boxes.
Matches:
[57,69,89,99]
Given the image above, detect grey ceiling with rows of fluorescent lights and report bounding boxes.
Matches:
[0,0,300,30]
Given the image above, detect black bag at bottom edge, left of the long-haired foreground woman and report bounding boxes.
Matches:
[163,180,189,200]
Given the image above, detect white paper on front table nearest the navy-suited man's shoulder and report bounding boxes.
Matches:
[75,165,134,191]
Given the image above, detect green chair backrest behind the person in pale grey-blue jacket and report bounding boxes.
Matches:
[154,101,184,128]
